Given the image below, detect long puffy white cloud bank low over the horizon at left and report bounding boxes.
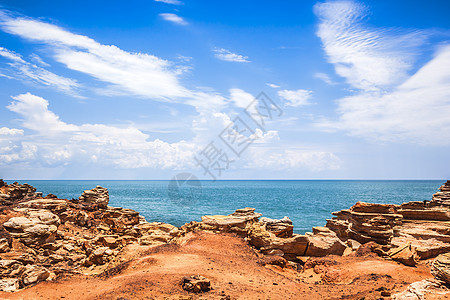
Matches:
[0,93,198,169]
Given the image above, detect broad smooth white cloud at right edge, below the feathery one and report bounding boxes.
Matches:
[318,45,450,145]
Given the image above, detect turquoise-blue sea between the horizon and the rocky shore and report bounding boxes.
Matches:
[7,180,444,233]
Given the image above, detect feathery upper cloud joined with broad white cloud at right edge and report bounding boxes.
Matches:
[315,1,450,145]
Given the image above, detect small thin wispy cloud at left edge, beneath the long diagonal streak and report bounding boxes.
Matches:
[0,47,80,97]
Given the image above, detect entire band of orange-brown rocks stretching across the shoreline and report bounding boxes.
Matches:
[0,181,450,291]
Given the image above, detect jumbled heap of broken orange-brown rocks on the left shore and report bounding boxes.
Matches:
[0,181,180,291]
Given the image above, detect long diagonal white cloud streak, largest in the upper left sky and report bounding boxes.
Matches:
[0,15,191,101]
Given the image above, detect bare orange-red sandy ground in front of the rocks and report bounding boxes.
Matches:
[0,232,446,300]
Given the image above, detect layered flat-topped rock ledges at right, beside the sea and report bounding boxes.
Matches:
[326,181,450,264]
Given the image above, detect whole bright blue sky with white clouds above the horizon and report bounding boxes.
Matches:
[0,0,450,179]
